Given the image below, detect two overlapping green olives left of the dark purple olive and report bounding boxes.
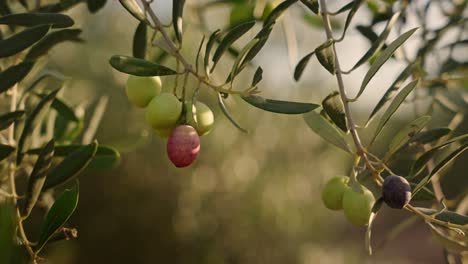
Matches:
[322,176,375,226]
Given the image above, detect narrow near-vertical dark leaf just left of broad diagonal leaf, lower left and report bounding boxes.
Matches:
[23,139,55,218]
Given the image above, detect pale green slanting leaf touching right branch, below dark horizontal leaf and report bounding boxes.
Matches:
[304,111,351,153]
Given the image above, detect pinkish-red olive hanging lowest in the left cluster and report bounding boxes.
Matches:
[167,125,200,168]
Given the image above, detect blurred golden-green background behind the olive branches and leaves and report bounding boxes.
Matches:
[15,0,468,264]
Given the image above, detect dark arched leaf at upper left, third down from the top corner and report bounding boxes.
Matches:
[25,29,83,60]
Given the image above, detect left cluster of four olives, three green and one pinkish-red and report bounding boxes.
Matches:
[126,75,214,168]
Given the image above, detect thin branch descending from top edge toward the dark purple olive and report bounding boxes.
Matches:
[320,0,382,185]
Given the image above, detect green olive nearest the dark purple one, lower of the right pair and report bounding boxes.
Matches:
[343,186,375,226]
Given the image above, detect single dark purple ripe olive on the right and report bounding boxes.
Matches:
[382,175,411,209]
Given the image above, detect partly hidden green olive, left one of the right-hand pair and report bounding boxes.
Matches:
[322,176,349,210]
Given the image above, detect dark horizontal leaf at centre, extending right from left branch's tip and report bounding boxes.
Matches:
[241,95,319,115]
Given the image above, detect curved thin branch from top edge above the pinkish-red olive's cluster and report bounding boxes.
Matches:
[141,0,245,95]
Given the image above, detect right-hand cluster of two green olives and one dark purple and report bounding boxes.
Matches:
[322,175,411,226]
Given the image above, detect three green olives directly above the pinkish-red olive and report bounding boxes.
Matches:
[126,75,214,138]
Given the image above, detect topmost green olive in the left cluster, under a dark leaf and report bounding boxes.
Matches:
[125,75,161,108]
